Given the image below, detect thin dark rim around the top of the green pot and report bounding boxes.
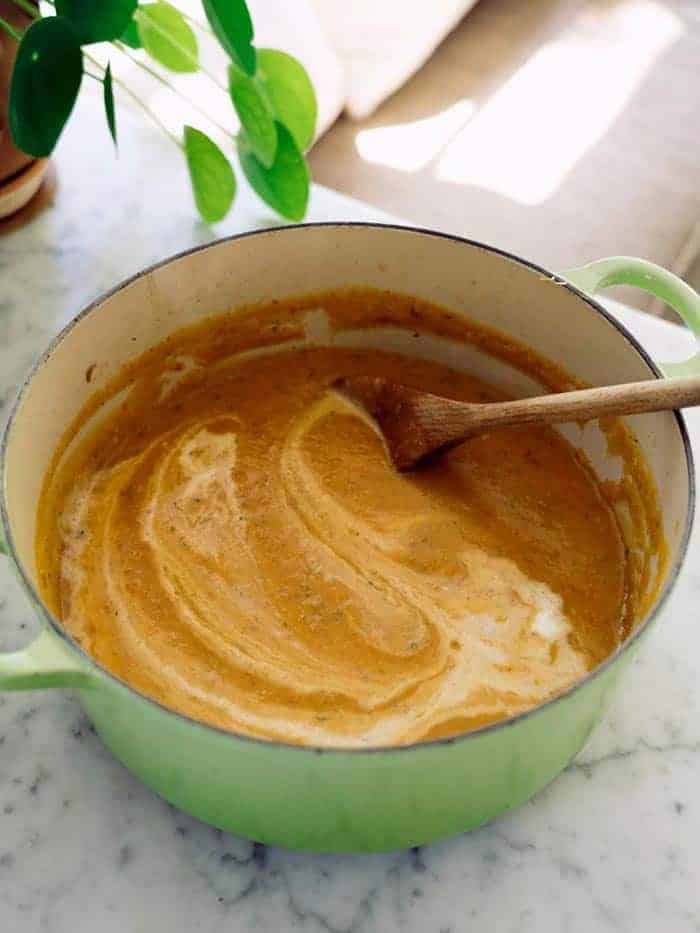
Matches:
[0,221,696,756]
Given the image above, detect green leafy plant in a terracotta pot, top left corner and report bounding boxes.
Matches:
[0,0,316,223]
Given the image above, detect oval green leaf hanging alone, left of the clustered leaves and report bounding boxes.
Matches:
[185,126,236,224]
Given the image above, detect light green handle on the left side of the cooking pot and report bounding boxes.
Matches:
[0,529,92,690]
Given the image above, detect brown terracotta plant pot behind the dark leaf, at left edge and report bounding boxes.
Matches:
[0,0,48,217]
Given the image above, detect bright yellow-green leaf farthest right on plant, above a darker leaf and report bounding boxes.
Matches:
[258,49,318,151]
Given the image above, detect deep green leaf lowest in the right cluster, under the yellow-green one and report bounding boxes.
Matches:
[238,121,309,220]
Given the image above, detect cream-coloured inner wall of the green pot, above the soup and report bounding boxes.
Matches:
[5,225,690,628]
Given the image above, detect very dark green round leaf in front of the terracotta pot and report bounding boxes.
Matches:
[8,16,83,156]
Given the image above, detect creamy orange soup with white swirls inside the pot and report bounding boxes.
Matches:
[38,292,659,746]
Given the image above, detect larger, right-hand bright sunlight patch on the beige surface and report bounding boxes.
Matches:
[435,0,684,205]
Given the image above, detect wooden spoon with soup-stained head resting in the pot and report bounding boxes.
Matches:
[333,376,700,472]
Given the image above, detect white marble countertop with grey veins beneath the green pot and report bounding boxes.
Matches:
[0,91,700,933]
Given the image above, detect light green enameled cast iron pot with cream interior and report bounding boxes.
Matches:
[0,224,700,851]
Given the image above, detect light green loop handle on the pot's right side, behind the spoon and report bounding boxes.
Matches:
[562,256,700,376]
